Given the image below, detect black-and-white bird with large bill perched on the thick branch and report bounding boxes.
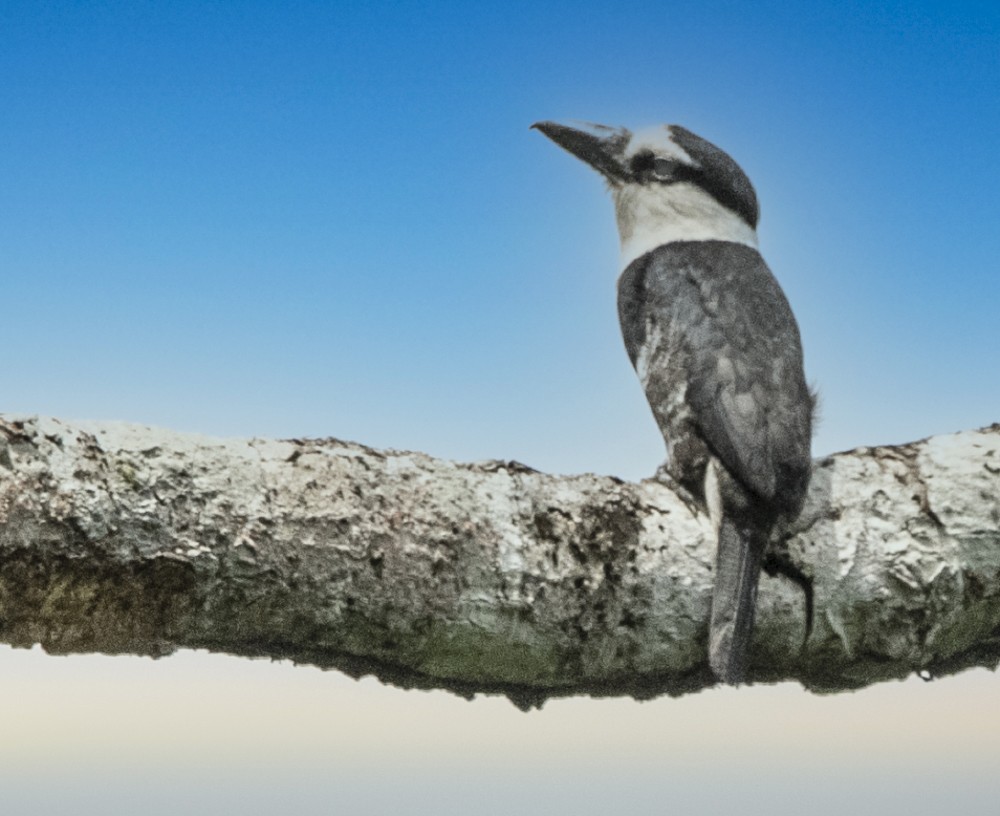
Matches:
[532,121,815,685]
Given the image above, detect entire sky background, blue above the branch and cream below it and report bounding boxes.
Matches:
[0,0,1000,816]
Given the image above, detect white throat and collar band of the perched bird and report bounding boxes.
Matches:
[611,181,757,270]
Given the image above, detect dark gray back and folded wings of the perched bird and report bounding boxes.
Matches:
[619,241,812,508]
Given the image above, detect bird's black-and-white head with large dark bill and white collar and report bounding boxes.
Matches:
[532,122,759,267]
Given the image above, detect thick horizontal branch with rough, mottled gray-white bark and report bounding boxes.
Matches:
[0,416,1000,706]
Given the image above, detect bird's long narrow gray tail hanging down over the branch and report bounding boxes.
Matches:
[708,513,767,685]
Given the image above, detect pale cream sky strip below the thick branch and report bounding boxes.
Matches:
[0,647,1000,816]
